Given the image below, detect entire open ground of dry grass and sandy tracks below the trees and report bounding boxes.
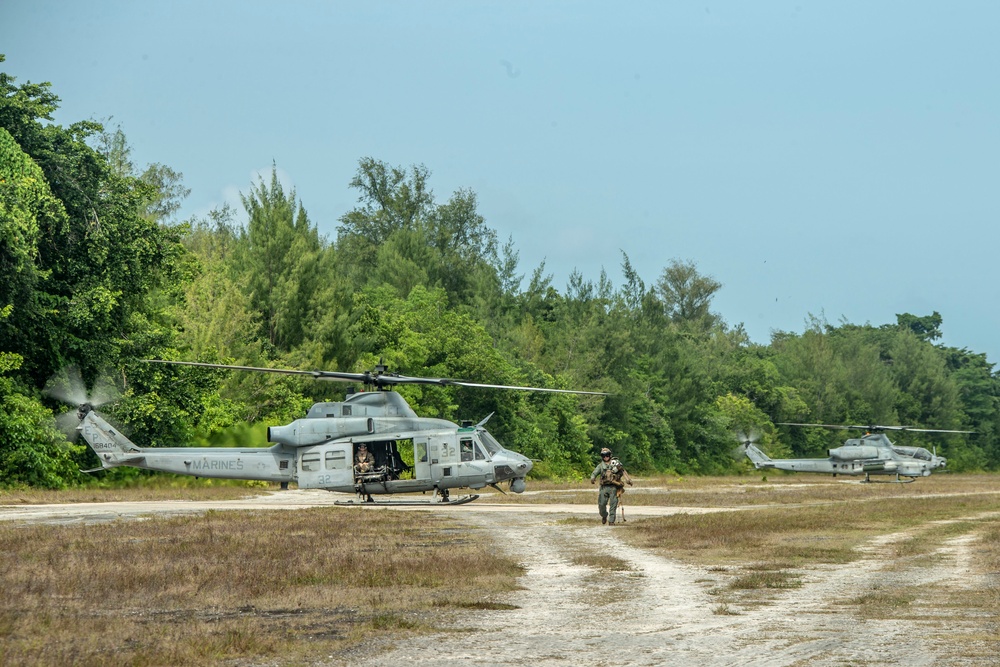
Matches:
[0,475,1000,665]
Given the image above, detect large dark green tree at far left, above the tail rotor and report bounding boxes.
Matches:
[0,62,183,387]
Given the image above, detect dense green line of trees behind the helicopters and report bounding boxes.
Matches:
[0,61,1000,487]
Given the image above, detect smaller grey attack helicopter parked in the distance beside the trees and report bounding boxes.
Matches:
[737,422,973,482]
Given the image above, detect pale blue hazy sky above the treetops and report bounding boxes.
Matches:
[0,0,1000,362]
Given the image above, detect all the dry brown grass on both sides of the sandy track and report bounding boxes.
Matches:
[0,475,1000,665]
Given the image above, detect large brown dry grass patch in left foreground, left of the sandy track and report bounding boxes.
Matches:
[0,509,521,665]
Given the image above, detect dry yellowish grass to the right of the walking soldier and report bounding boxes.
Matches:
[622,476,1000,640]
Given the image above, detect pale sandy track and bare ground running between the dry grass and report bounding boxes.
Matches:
[0,491,1000,667]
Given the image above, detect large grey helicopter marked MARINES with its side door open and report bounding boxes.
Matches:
[77,359,605,504]
